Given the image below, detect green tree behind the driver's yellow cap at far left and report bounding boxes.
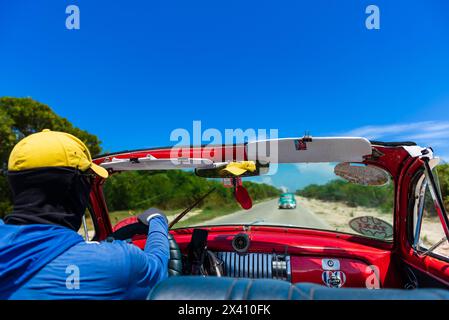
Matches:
[0,97,101,216]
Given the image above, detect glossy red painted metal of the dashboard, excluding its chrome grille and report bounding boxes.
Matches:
[114,217,399,287]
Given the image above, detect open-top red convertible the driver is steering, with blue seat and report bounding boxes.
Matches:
[83,137,449,300]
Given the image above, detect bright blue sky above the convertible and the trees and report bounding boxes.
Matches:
[0,0,449,189]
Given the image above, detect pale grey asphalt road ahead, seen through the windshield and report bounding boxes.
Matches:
[201,199,331,229]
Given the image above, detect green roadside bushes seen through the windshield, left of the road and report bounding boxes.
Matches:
[104,170,281,226]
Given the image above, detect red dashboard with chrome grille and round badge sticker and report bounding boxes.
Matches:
[128,226,401,288]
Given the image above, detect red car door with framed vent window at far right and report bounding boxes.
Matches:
[402,162,449,288]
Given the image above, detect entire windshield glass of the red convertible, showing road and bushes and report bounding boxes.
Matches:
[105,163,394,241]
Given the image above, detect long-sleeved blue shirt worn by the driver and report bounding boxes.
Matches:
[0,217,169,299]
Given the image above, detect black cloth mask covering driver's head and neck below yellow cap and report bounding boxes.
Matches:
[5,167,91,231]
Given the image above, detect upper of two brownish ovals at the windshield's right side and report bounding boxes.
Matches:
[334,162,390,186]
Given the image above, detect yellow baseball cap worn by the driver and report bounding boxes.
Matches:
[8,129,108,179]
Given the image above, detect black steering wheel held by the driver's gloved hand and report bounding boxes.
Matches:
[110,222,182,277]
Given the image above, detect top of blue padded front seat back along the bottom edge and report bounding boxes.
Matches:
[148,276,449,300]
